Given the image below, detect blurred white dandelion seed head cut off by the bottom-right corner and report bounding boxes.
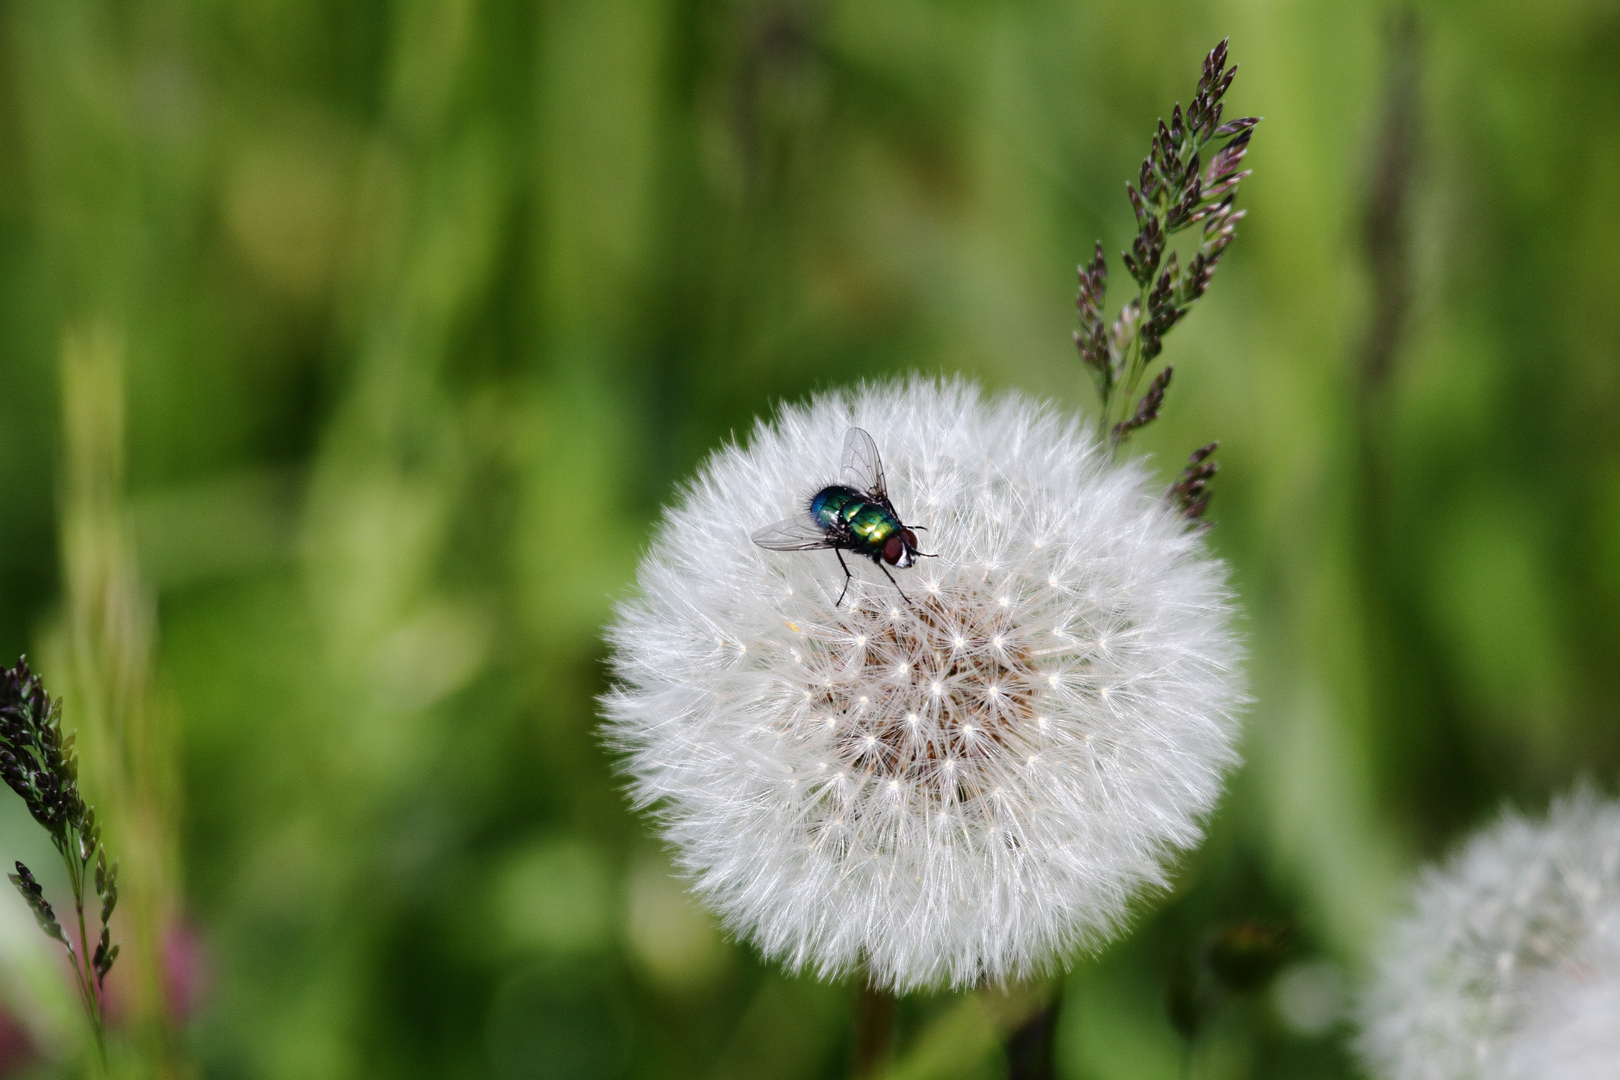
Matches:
[1358,790,1620,1080]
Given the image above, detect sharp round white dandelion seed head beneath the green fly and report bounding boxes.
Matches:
[604,379,1241,989]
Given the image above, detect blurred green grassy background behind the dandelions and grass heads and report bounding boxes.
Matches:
[0,0,1620,1080]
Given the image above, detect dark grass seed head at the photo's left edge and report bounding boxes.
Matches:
[0,657,118,1023]
